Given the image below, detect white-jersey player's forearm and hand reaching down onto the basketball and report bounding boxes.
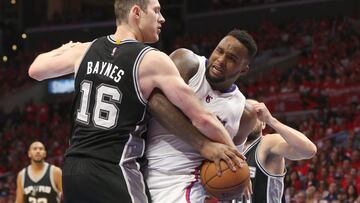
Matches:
[148,89,243,172]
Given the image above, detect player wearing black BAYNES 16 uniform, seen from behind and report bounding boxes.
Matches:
[29,0,242,203]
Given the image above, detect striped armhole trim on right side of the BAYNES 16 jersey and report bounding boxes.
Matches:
[133,46,155,106]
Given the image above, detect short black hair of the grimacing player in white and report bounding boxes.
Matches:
[226,29,257,58]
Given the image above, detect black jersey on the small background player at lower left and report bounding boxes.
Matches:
[23,163,60,203]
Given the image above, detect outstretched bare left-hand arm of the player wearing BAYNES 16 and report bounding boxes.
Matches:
[28,42,90,81]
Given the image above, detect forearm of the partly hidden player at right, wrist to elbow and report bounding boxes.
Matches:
[267,117,316,158]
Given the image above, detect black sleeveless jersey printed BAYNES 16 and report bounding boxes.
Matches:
[66,36,154,164]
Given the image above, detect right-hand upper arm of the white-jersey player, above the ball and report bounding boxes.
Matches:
[233,101,257,145]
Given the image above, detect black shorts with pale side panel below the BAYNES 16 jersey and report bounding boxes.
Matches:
[62,157,150,203]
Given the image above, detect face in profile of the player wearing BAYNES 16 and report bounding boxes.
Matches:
[139,0,165,43]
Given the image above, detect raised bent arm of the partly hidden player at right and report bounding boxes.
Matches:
[253,103,317,160]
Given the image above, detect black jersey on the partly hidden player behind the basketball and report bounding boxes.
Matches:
[240,136,286,203]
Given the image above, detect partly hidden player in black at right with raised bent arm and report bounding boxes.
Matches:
[233,99,316,203]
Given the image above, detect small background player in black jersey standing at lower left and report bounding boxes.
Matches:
[16,141,62,203]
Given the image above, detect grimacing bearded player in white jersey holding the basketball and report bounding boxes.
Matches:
[145,30,257,203]
